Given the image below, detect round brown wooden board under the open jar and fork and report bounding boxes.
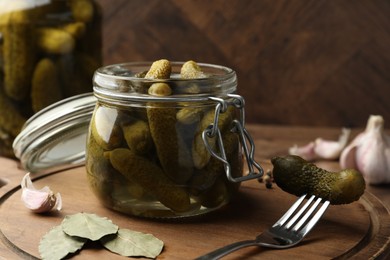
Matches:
[0,161,389,259]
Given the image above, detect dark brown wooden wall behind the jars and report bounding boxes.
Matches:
[98,0,390,127]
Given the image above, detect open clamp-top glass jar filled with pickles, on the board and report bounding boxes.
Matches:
[86,62,262,218]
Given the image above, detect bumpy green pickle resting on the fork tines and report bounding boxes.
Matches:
[271,155,365,204]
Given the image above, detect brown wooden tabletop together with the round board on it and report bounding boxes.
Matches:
[0,125,390,259]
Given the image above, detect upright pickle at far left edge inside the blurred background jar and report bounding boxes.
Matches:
[0,10,35,101]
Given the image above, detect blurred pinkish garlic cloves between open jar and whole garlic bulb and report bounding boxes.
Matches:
[289,128,351,161]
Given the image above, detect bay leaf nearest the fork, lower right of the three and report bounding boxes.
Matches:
[100,229,164,258]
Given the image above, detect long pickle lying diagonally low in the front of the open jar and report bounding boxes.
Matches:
[106,148,191,212]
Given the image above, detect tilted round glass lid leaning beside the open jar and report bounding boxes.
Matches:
[13,93,96,172]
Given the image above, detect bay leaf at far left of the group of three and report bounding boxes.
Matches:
[39,226,87,260]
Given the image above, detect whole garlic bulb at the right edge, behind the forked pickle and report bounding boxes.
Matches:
[340,115,390,184]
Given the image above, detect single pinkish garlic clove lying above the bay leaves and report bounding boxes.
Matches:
[20,173,62,213]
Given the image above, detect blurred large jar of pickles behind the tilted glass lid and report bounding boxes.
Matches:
[0,0,102,158]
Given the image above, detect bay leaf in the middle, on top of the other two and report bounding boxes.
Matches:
[61,213,118,241]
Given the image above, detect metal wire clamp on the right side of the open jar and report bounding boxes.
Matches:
[202,94,264,182]
